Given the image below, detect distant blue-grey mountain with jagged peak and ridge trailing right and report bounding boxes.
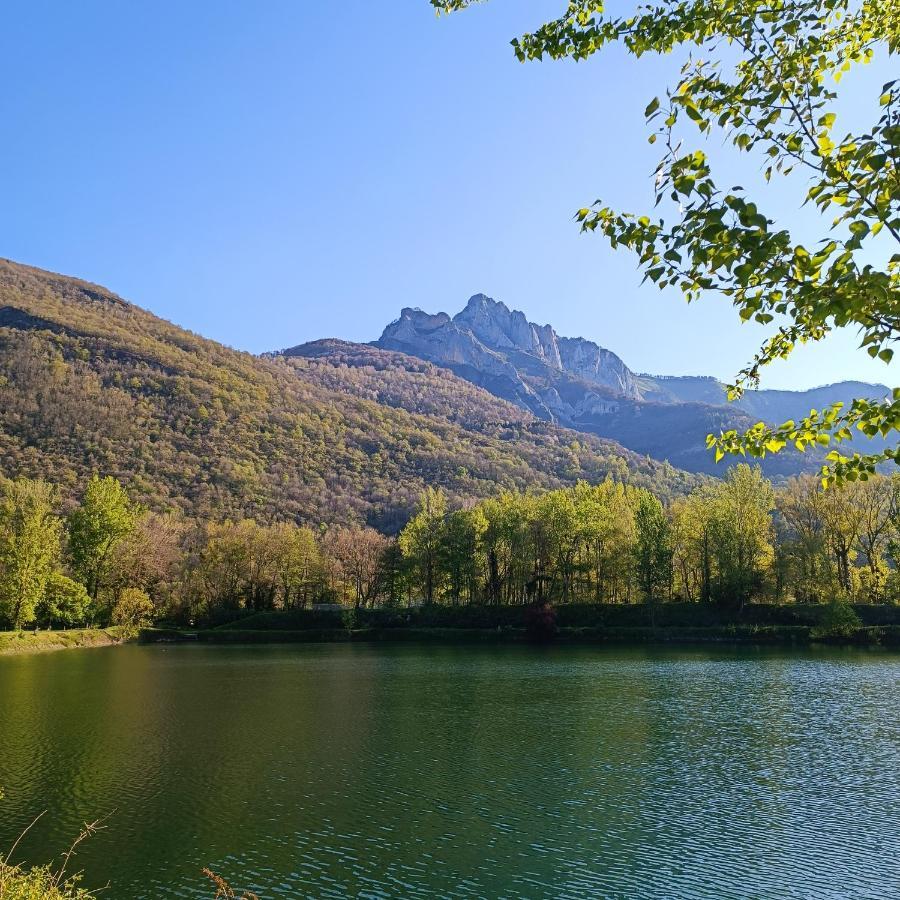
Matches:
[375,294,888,477]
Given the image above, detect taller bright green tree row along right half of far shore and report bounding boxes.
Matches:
[399,465,900,607]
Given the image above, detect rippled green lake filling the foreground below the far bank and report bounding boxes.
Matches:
[0,644,900,900]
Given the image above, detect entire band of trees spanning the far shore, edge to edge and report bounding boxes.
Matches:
[0,465,900,628]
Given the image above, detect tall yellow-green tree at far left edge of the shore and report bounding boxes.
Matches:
[0,478,62,628]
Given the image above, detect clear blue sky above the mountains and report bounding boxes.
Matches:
[0,0,893,388]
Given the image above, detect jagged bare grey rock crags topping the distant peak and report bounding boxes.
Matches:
[376,294,641,424]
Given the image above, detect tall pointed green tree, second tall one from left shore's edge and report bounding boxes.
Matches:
[69,475,138,602]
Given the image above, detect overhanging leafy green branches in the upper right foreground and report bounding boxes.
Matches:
[431,0,900,484]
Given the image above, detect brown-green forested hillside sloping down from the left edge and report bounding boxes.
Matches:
[0,260,695,531]
